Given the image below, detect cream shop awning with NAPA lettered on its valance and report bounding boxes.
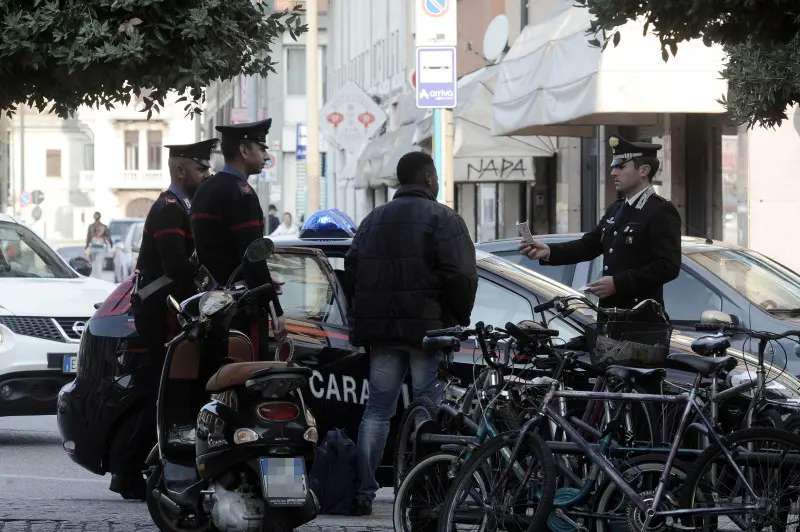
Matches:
[414,65,556,159]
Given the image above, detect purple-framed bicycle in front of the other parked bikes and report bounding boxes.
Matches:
[439,331,800,531]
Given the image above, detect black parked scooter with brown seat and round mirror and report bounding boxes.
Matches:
[147,238,319,532]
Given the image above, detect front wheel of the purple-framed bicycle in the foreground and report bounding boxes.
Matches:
[438,432,557,532]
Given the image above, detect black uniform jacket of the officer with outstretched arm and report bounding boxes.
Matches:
[541,189,681,311]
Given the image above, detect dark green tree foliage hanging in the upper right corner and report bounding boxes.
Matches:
[577,0,800,127]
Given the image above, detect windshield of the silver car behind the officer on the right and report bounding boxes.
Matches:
[689,249,800,312]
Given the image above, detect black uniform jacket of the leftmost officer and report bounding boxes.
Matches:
[136,190,198,315]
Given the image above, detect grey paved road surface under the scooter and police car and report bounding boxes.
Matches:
[0,416,392,532]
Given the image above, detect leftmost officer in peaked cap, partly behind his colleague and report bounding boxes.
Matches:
[109,139,219,499]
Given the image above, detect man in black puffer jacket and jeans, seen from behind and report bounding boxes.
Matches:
[345,152,478,515]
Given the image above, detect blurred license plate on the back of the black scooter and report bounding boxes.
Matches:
[260,456,308,507]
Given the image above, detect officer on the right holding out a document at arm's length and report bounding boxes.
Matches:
[520,136,681,321]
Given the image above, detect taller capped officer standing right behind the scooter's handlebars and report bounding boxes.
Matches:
[191,118,285,358]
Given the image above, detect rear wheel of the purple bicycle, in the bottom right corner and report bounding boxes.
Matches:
[680,427,800,532]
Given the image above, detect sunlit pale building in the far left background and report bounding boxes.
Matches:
[3,95,196,242]
